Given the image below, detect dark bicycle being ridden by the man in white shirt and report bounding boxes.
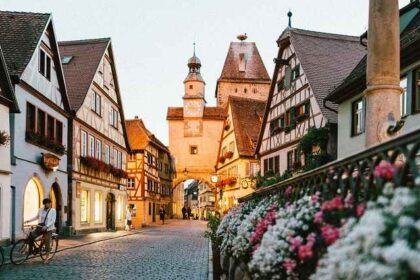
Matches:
[10,227,58,265]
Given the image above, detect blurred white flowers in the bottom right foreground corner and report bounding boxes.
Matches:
[312,185,420,280]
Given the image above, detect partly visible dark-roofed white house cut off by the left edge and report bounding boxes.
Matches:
[0,44,19,246]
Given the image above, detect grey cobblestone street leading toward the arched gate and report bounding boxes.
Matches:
[0,220,208,280]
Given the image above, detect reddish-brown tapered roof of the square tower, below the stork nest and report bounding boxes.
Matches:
[218,42,270,82]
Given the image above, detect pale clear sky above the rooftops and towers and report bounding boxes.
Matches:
[0,0,409,144]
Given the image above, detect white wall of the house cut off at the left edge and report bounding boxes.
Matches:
[0,104,12,242]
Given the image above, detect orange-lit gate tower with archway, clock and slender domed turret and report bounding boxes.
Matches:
[167,53,225,214]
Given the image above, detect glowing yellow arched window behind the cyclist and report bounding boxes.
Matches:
[22,178,44,226]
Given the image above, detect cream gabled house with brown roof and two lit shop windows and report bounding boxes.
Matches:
[59,38,129,232]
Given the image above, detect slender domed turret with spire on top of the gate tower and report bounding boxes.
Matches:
[183,51,206,118]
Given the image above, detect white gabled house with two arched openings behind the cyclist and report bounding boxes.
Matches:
[0,12,70,237]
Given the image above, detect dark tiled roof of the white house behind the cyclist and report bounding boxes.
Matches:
[0,11,51,77]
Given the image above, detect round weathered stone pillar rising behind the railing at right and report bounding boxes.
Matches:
[365,0,402,147]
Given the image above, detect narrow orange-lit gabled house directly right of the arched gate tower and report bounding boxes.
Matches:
[216,96,266,212]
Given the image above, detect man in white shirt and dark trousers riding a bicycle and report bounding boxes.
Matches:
[25,198,57,263]
